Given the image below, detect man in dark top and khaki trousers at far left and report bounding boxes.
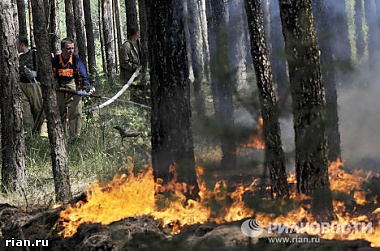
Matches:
[17,37,42,137]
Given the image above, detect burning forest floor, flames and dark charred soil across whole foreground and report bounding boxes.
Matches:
[0,155,380,250]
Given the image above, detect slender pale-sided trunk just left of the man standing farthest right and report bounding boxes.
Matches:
[102,0,116,80]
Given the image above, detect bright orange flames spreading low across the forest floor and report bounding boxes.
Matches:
[57,160,380,247]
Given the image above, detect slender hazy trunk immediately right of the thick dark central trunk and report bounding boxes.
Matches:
[187,0,206,117]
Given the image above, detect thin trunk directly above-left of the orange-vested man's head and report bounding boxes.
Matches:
[49,0,61,54]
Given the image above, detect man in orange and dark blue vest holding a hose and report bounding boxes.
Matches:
[52,38,90,143]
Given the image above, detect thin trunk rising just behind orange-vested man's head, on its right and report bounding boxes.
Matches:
[72,0,85,65]
